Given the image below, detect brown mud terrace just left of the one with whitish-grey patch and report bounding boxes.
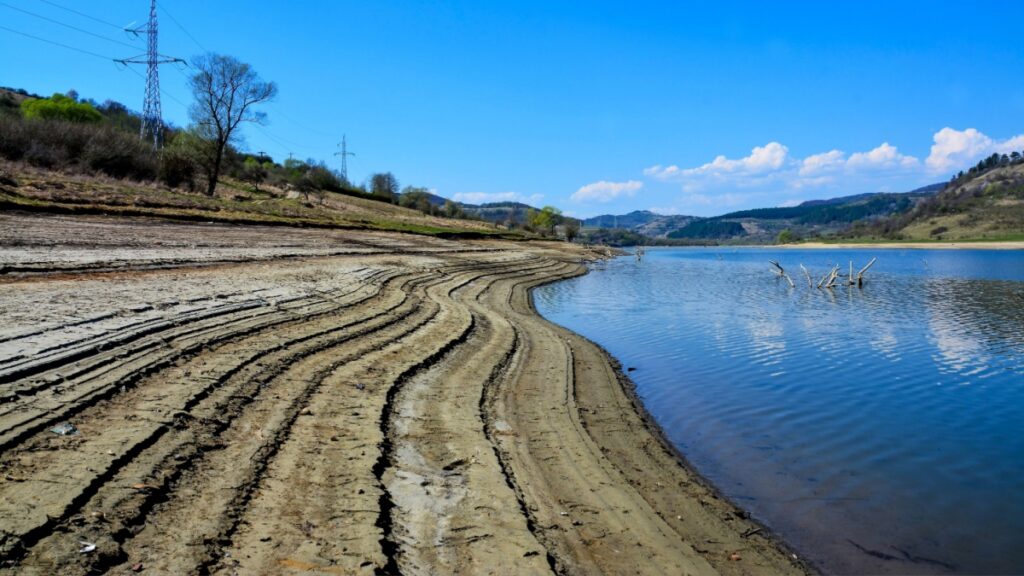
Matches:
[198,258,565,573]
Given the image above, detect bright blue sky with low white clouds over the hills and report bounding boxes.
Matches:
[0,0,1024,216]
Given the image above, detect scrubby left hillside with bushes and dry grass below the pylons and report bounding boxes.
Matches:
[0,88,521,237]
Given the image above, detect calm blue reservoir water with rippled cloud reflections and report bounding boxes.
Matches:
[535,248,1024,574]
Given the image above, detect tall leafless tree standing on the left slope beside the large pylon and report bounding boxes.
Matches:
[189,53,278,196]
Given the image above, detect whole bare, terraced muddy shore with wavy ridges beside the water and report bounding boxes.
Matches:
[0,215,806,575]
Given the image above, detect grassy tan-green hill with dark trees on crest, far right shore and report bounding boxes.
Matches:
[843,153,1024,240]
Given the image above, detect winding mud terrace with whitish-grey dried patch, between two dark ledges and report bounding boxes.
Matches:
[378,262,577,574]
